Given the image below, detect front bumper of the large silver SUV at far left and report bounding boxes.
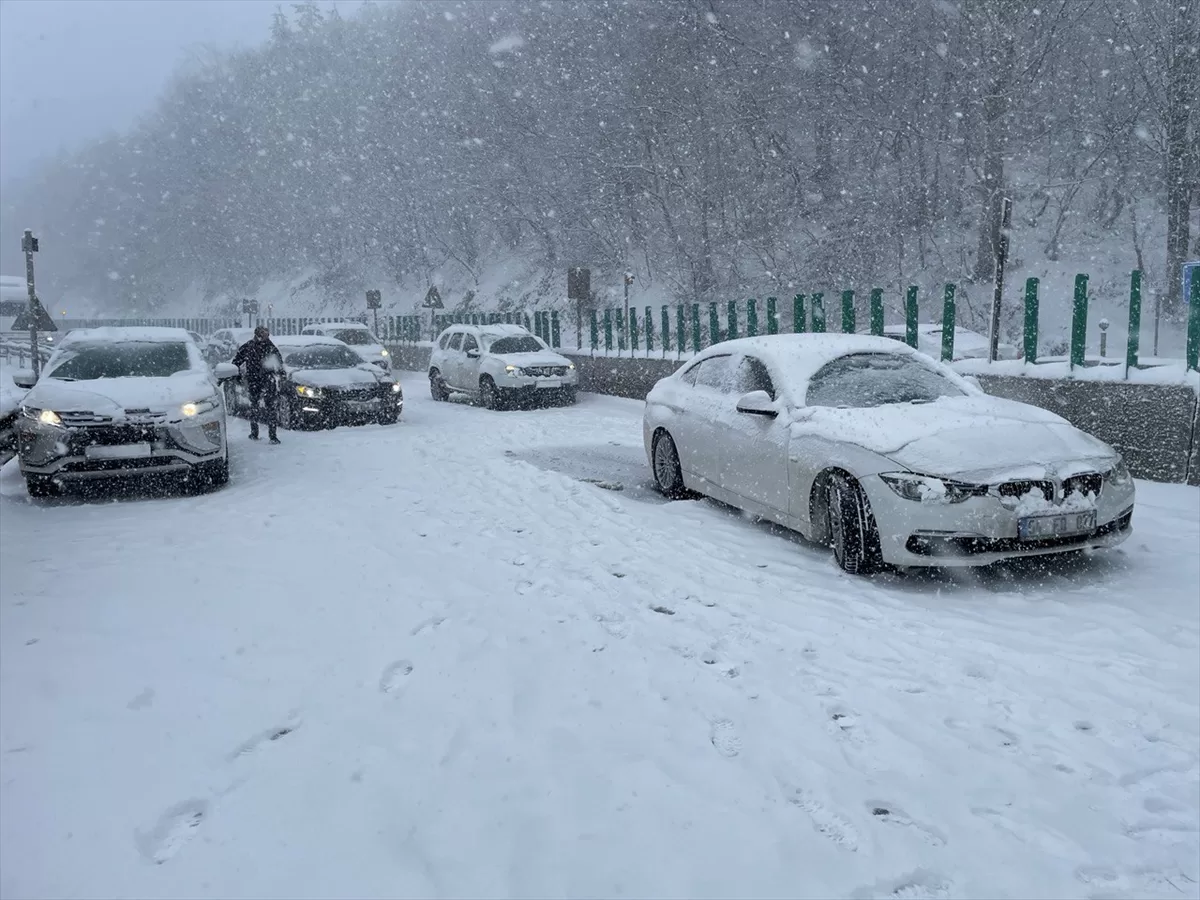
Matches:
[17,416,226,482]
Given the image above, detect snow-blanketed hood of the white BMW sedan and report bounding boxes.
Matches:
[792,395,1116,480]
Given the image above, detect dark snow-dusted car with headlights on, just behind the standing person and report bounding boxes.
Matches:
[226,335,404,430]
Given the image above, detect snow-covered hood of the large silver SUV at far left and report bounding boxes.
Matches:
[24,372,216,419]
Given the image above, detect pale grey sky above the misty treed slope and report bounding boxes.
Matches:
[0,0,359,184]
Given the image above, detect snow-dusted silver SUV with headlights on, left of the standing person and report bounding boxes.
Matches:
[13,328,236,497]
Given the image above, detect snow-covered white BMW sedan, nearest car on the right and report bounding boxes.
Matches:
[643,335,1134,574]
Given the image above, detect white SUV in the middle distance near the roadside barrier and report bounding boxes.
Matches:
[430,325,580,409]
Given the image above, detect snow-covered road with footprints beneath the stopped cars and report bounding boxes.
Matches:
[0,376,1200,898]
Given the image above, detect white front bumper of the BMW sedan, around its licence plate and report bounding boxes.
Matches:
[863,478,1134,568]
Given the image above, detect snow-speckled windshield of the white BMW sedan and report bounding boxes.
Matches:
[808,353,966,409]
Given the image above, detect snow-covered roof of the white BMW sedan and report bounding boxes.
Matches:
[679,334,976,403]
